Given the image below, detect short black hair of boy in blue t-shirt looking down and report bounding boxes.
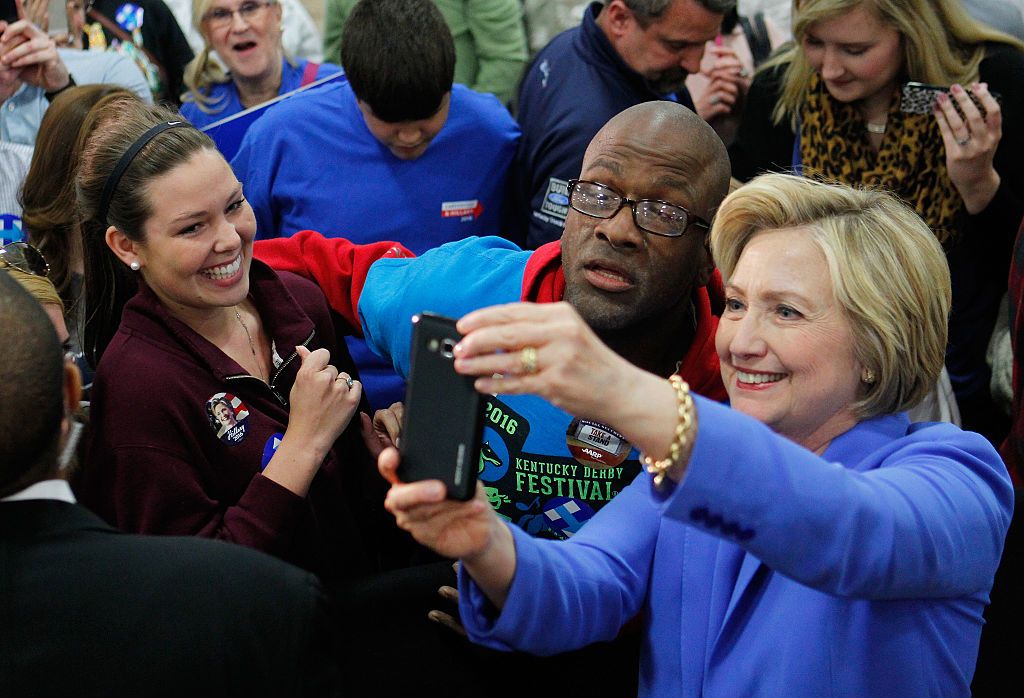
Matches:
[341,0,455,124]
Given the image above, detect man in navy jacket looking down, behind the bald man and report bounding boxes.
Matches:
[513,0,740,248]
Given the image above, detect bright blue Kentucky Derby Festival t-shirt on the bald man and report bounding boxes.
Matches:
[358,237,640,539]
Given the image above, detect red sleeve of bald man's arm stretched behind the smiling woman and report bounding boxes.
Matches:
[253,230,416,332]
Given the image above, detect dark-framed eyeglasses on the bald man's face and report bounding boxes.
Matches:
[569,179,711,237]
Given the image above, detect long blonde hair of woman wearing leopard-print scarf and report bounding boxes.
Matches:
[761,0,1024,129]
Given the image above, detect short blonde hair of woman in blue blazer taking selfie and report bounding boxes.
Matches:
[711,174,951,419]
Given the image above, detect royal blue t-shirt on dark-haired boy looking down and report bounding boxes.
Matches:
[231,83,519,408]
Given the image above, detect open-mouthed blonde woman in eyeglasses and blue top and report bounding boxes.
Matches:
[181,0,341,128]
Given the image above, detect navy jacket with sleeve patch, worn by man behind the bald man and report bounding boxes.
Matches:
[515,3,693,248]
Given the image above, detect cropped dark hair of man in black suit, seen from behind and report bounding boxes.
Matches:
[0,269,63,497]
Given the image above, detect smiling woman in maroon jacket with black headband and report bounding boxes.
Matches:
[77,99,389,587]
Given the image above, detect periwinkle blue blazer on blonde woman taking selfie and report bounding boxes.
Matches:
[460,398,1013,698]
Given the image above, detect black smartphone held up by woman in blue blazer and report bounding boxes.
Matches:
[398,312,483,500]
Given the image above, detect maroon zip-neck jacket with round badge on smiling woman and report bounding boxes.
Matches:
[76,260,388,585]
